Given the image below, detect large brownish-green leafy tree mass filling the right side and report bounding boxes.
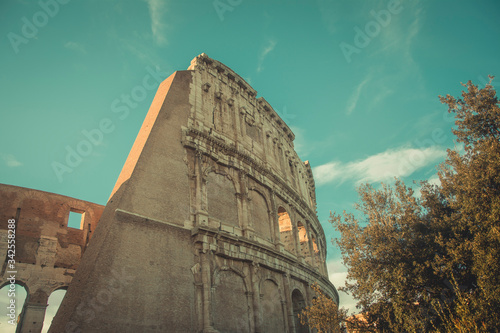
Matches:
[331,77,500,332]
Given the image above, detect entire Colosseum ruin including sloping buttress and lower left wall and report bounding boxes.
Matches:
[0,54,338,333]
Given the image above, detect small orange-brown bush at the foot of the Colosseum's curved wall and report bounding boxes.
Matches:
[298,283,347,333]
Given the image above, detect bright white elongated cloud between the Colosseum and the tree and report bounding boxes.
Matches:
[313,146,446,185]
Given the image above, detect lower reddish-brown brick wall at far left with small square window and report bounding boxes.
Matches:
[0,184,104,332]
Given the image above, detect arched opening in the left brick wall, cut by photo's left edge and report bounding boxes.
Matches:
[0,281,28,333]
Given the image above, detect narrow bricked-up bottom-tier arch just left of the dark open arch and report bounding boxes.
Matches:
[260,278,286,332]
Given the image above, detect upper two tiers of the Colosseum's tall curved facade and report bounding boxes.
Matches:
[182,54,326,264]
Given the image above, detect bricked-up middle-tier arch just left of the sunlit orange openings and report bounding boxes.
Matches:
[248,188,273,241]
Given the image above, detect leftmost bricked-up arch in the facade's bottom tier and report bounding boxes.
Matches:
[211,267,251,333]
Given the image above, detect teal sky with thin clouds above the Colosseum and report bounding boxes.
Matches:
[0,0,500,316]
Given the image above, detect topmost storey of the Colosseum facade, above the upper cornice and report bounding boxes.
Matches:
[188,54,316,211]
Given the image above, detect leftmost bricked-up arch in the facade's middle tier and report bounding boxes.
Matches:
[206,172,239,227]
